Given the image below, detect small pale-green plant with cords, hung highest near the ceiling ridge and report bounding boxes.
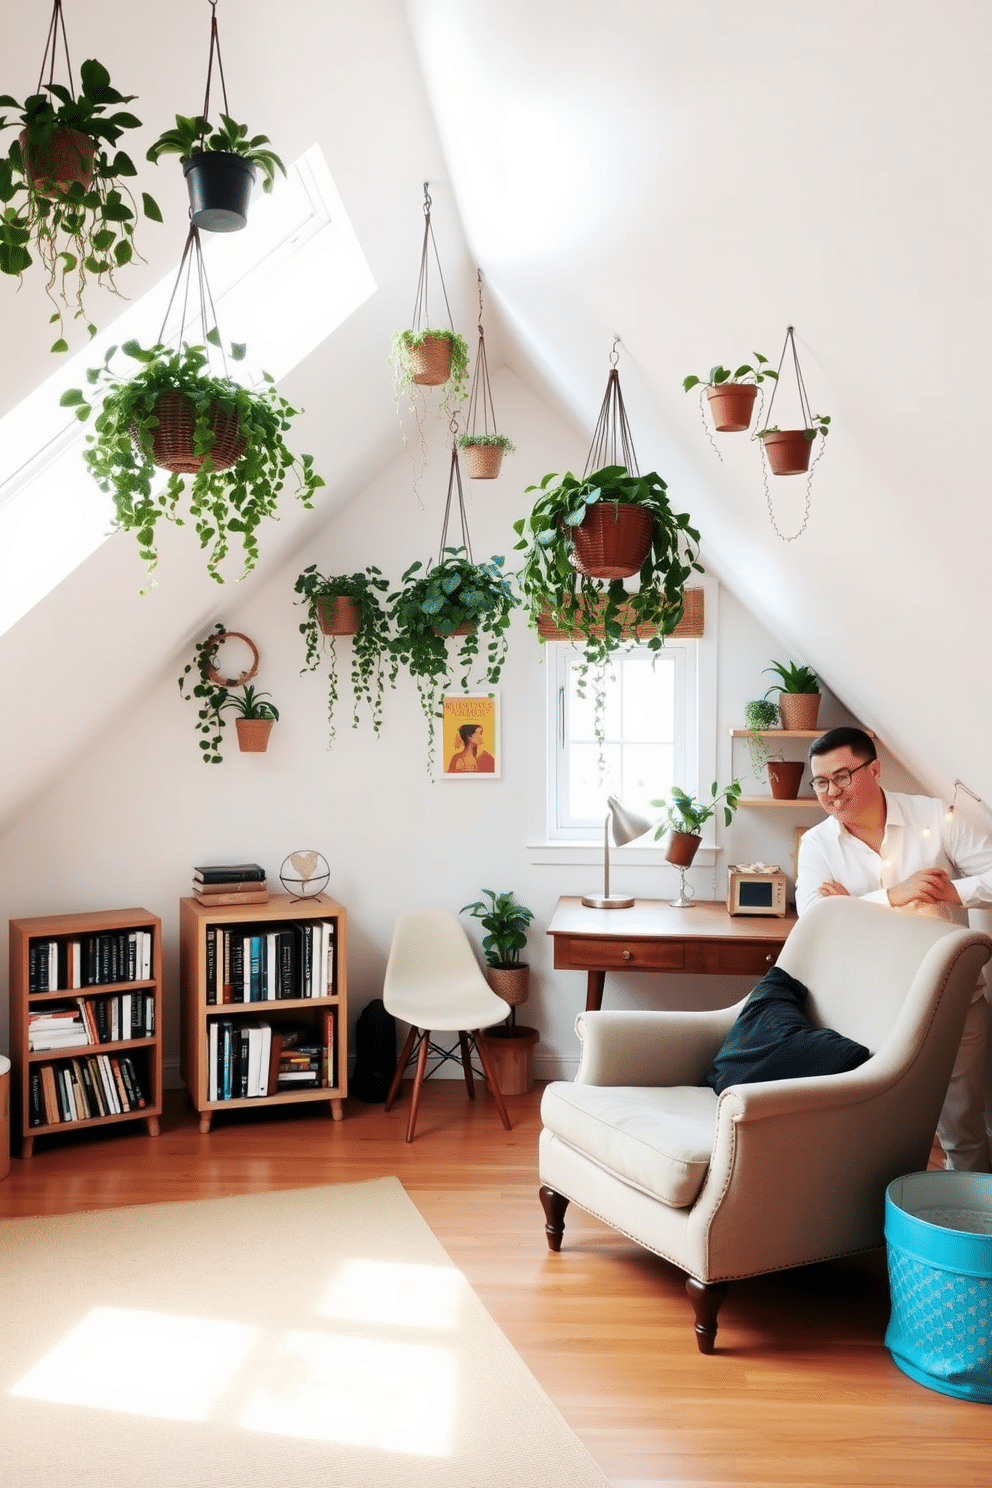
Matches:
[390,182,468,488]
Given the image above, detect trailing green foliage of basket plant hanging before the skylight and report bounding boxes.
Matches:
[61,330,324,592]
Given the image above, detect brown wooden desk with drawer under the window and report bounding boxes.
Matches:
[547,899,796,1012]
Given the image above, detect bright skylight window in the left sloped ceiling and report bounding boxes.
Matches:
[0,144,376,634]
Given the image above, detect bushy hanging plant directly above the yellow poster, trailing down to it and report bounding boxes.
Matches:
[387,548,519,768]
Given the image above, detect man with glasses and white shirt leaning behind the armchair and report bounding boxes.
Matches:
[796,728,992,1173]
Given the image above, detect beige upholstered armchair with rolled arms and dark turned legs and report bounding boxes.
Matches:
[540,897,992,1354]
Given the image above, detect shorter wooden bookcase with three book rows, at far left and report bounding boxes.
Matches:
[10,909,162,1158]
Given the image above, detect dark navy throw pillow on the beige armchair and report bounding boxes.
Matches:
[706,966,872,1095]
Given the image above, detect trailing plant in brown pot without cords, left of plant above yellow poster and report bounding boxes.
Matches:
[294,564,396,747]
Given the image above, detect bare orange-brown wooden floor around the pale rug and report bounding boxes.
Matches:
[0,1082,992,1488]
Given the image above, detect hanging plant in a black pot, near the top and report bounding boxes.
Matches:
[146,113,286,232]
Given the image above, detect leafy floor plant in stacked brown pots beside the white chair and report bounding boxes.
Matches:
[461,888,538,1095]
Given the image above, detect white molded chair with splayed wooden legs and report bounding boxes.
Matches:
[382,909,510,1141]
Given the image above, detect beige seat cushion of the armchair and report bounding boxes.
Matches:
[541,1080,717,1208]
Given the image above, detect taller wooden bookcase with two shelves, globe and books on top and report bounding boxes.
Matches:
[178,894,348,1132]
